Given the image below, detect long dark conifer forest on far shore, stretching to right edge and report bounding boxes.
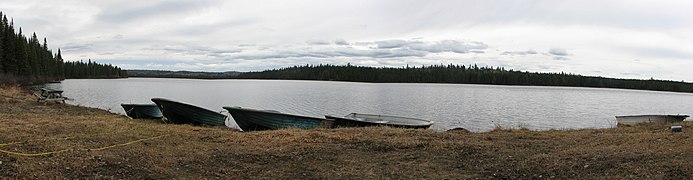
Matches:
[236,64,693,92]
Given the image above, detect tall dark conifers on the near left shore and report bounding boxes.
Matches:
[0,12,126,84]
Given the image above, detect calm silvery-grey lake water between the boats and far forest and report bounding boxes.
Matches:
[46,78,693,131]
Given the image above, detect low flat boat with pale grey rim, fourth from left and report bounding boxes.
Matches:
[325,113,433,129]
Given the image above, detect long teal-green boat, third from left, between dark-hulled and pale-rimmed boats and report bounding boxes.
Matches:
[224,106,332,131]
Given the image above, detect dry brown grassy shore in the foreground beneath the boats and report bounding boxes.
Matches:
[0,88,693,179]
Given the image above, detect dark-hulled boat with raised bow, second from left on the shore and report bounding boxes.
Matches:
[152,98,226,126]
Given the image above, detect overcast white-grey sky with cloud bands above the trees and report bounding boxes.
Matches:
[0,0,693,82]
